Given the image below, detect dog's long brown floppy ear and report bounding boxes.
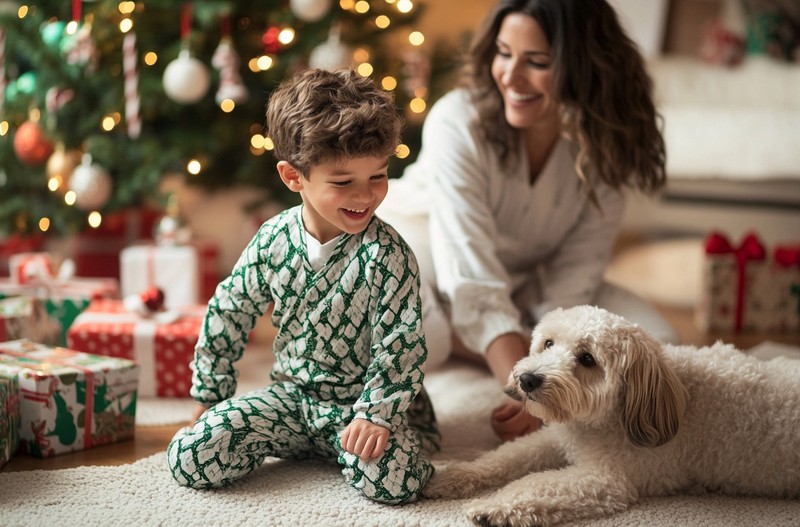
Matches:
[617,328,688,447]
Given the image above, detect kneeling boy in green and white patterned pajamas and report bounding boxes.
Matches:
[167,70,440,503]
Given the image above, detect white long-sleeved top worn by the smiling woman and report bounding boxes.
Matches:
[390,89,625,353]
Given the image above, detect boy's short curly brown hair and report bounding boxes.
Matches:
[266,69,402,177]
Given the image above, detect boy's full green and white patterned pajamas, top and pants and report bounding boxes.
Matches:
[167,206,440,503]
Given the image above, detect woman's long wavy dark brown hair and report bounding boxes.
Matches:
[465,0,666,197]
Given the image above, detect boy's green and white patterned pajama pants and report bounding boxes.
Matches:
[167,383,439,504]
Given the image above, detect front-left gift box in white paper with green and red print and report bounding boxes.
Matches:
[0,340,139,457]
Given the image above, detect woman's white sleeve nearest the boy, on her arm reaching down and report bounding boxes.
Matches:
[422,92,528,353]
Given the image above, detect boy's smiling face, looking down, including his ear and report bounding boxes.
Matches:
[278,157,389,243]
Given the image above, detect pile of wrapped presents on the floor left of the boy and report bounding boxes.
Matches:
[0,210,216,466]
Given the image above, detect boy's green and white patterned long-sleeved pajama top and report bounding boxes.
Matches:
[191,205,427,429]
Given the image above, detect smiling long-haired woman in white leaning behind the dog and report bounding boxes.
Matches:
[378,0,677,439]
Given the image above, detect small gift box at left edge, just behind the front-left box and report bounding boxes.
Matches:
[0,296,61,344]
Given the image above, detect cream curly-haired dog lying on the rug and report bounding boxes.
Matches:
[425,306,800,527]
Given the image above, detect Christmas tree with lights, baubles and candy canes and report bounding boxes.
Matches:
[0,0,430,236]
